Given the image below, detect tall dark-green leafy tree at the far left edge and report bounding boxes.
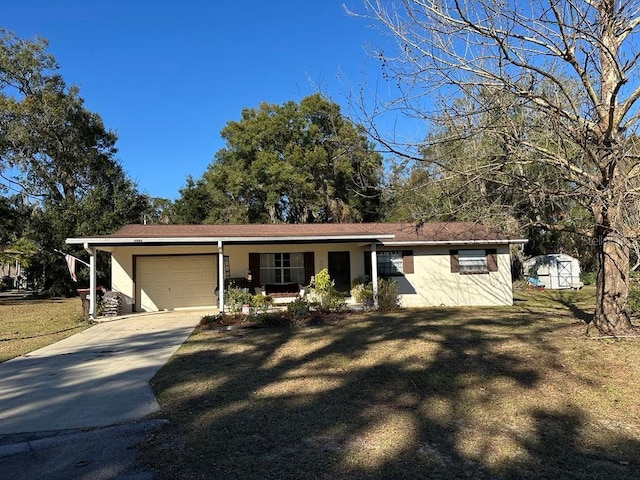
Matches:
[0,30,148,293]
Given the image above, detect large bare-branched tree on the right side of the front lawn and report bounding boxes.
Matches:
[365,0,640,335]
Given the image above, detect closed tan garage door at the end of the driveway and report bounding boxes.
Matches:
[136,255,216,312]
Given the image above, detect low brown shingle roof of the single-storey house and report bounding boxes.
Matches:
[94,222,510,244]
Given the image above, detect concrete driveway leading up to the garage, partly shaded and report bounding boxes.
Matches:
[0,311,207,435]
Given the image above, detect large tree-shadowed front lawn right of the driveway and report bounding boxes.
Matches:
[143,289,640,479]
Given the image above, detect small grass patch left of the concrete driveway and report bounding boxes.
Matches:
[0,298,89,362]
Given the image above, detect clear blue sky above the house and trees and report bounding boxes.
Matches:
[5,0,392,199]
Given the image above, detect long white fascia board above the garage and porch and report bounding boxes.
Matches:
[66,234,395,246]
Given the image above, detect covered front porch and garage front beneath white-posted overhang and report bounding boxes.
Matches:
[68,229,390,318]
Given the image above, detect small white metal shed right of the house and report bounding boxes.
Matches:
[523,253,583,290]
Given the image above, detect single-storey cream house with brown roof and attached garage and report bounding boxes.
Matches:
[67,222,526,313]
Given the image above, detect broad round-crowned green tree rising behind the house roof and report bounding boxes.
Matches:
[176,95,382,223]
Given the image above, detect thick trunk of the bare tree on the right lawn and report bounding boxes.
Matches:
[589,228,633,335]
